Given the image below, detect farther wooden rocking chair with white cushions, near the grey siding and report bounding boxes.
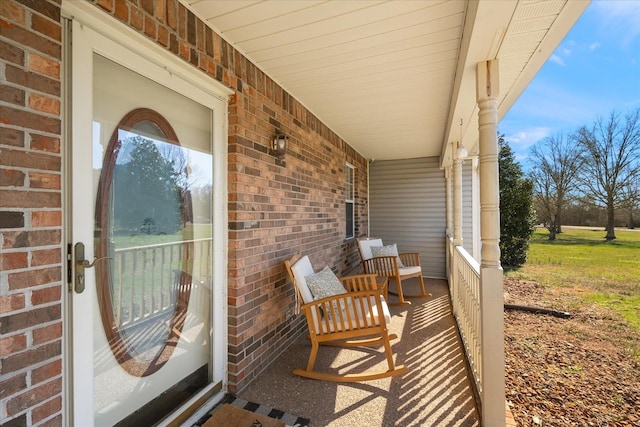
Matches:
[358,238,431,305]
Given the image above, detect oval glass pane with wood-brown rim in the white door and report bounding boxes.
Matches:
[95,108,197,377]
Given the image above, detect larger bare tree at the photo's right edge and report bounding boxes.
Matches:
[576,109,640,240]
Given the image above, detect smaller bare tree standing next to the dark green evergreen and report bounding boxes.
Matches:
[531,134,584,240]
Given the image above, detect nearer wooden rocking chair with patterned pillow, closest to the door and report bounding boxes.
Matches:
[285,254,408,382]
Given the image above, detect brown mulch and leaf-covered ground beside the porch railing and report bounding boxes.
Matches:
[504,277,640,427]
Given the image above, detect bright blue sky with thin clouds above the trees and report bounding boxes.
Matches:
[498,0,640,169]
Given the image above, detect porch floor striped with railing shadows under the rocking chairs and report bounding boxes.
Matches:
[230,279,480,427]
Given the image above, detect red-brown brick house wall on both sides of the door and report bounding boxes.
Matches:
[0,0,367,427]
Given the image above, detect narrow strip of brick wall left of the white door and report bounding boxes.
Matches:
[0,0,63,426]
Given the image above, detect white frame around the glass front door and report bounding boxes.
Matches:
[62,1,234,425]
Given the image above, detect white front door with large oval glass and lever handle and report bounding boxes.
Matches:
[69,12,226,426]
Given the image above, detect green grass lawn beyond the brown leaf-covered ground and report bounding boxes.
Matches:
[505,226,640,331]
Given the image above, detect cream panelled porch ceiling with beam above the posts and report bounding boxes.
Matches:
[182,0,588,164]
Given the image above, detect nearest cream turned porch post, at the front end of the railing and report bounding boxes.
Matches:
[476,60,505,426]
